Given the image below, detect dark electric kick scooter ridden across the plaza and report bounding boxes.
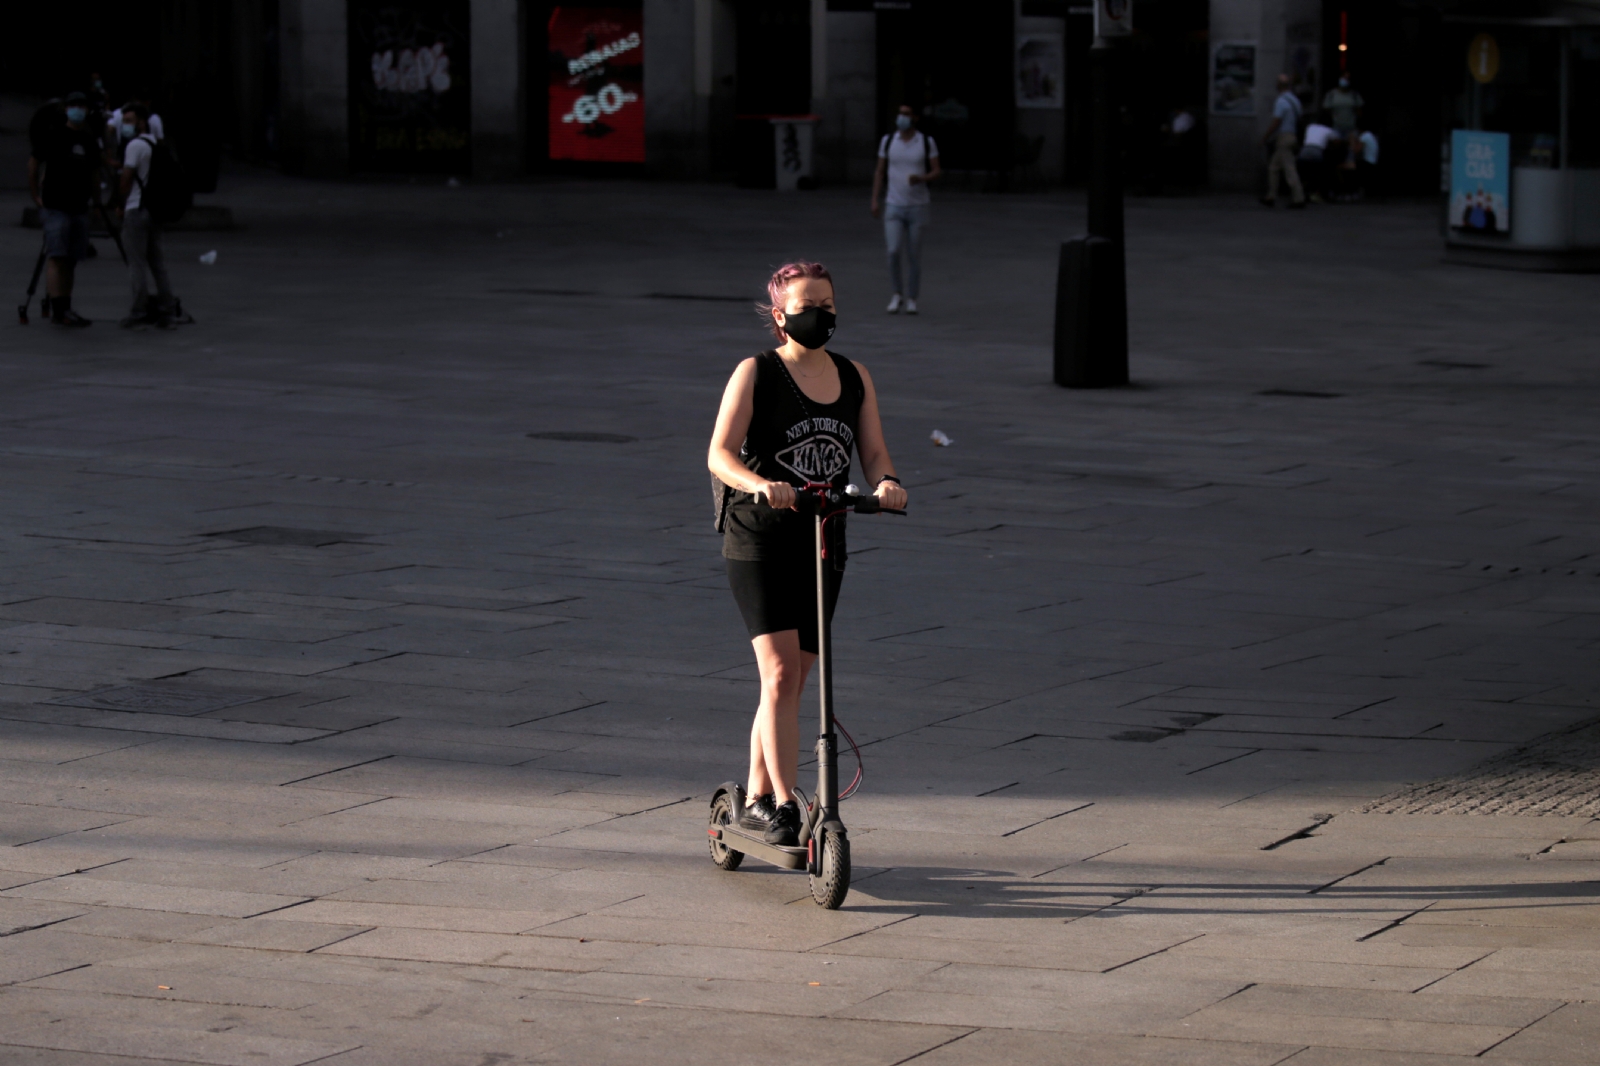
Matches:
[706,483,906,911]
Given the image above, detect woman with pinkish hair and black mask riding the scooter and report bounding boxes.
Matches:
[706,262,906,847]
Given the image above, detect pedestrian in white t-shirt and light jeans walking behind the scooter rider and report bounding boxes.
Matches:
[872,104,942,315]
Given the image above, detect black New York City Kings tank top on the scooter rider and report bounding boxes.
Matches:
[722,351,867,568]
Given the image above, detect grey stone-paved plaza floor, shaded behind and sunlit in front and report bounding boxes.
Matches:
[0,173,1600,1066]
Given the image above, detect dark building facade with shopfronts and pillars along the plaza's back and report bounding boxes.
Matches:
[12,0,1600,227]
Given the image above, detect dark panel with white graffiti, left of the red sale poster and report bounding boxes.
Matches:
[347,0,472,174]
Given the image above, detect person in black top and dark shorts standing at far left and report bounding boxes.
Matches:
[27,93,102,327]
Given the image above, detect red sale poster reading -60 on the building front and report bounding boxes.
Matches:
[549,5,645,163]
